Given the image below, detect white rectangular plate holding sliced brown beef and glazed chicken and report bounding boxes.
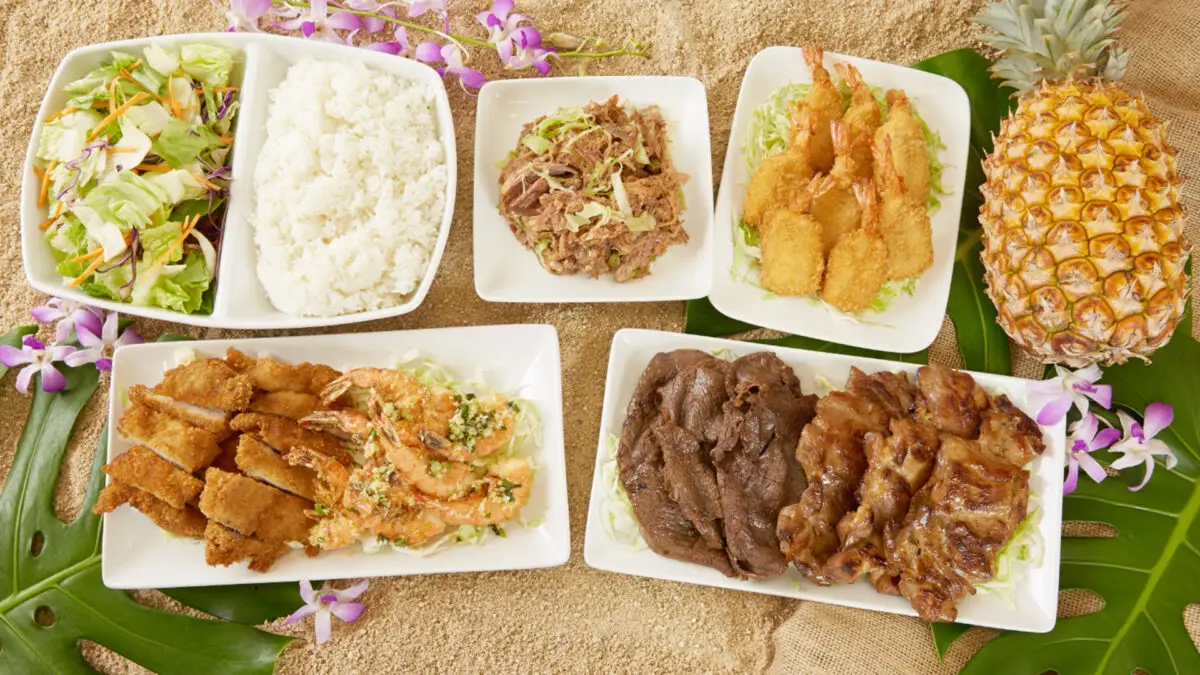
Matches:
[583,329,1066,633]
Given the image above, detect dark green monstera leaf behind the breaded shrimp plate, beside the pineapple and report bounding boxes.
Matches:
[684,49,1012,375]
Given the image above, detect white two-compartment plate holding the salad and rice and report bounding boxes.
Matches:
[20,32,457,329]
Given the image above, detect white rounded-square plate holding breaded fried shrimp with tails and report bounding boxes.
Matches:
[709,47,971,353]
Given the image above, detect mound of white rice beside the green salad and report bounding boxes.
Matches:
[251,59,446,316]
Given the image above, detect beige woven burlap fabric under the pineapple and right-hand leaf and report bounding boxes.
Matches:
[769,0,1200,675]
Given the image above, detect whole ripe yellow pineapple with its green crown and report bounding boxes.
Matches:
[977,0,1189,368]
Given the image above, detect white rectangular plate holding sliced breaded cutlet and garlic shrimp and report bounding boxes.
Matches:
[102,325,571,589]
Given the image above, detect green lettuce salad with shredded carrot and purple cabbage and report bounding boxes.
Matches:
[34,44,240,313]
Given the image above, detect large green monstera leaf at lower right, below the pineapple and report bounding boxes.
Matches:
[955,317,1200,675]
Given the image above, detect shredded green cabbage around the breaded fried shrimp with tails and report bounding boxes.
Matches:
[730,78,947,321]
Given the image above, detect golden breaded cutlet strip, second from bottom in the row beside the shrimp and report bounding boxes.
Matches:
[200,468,313,542]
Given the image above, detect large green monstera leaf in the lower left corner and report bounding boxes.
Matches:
[0,343,296,674]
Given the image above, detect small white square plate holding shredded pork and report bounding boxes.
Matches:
[474,77,713,303]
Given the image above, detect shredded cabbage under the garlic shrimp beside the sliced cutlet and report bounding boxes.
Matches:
[361,351,546,557]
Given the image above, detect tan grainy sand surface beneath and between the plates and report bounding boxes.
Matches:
[0,0,1190,673]
